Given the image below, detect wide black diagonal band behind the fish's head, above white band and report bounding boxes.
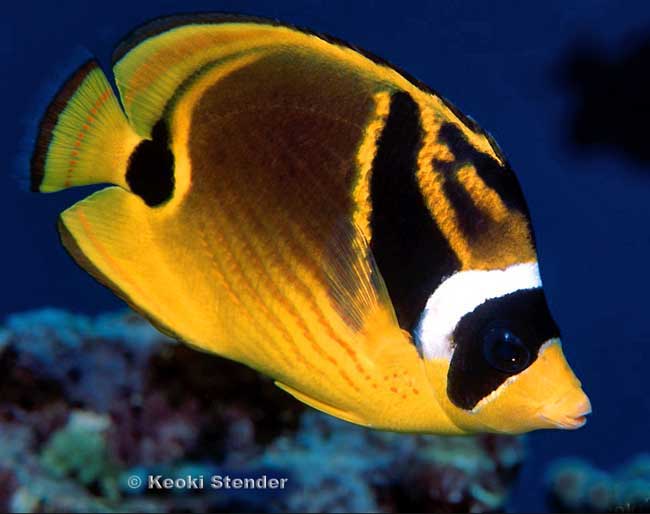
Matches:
[370,92,460,330]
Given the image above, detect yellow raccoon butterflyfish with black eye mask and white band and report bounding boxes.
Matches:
[31,15,590,434]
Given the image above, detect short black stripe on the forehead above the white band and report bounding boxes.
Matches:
[438,123,529,216]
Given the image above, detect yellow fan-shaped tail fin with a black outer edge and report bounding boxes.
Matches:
[30,60,141,193]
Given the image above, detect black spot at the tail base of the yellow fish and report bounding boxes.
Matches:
[126,120,174,207]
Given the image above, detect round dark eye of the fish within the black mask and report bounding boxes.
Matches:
[483,324,531,374]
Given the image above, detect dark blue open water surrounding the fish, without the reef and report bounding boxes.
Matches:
[0,0,650,510]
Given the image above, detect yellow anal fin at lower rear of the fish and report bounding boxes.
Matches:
[59,187,226,355]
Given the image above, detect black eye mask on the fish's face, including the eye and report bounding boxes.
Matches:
[447,288,560,410]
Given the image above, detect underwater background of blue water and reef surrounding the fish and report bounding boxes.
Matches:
[0,0,650,512]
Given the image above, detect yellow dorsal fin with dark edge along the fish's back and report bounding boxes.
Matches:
[113,13,450,137]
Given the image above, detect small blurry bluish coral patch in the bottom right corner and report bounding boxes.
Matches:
[547,454,650,512]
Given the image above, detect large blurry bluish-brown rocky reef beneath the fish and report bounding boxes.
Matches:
[0,310,524,512]
